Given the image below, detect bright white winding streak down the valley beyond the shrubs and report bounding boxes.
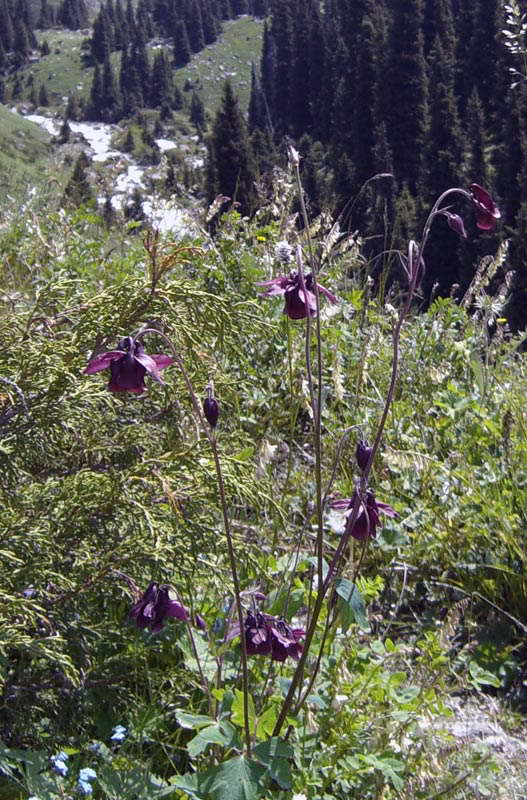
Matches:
[11,108,203,238]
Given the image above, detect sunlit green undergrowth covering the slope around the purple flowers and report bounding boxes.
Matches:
[0,173,527,800]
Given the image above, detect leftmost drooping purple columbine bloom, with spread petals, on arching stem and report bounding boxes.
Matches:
[84,336,174,394]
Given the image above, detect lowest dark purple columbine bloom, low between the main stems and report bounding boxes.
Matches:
[232,611,306,661]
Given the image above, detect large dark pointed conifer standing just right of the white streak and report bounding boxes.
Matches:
[207,81,255,214]
